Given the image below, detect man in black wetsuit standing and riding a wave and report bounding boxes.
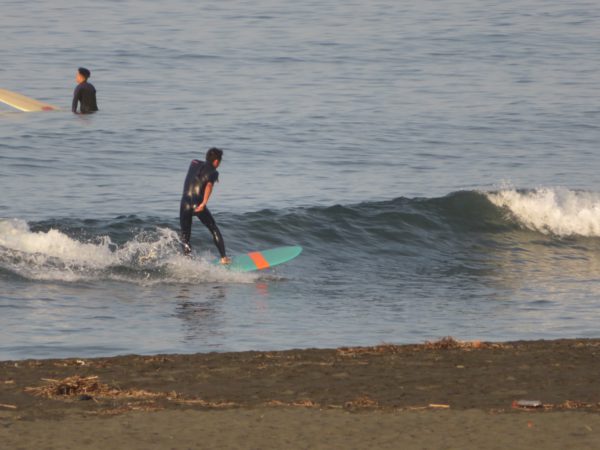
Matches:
[179,147,231,264]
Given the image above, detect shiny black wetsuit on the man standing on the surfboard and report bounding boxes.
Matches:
[179,159,226,258]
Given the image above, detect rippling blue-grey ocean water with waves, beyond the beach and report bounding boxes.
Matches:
[0,0,600,359]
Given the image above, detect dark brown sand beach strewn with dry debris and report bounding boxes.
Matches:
[0,340,600,450]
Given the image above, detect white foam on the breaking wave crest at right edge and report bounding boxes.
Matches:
[486,188,600,237]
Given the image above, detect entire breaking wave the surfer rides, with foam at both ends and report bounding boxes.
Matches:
[0,188,600,283]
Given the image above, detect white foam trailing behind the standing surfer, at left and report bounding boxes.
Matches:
[0,219,257,284]
